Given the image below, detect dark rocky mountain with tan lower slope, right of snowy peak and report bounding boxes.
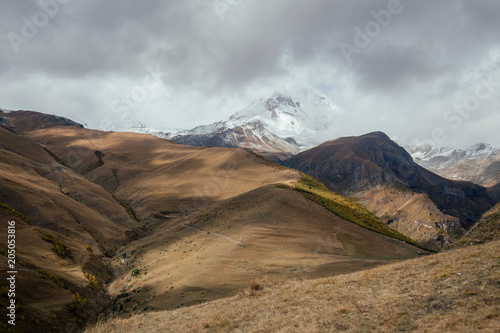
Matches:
[284,132,494,247]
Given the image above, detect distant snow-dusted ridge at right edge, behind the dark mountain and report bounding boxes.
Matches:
[405,143,500,186]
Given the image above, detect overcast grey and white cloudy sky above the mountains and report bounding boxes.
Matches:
[0,0,500,147]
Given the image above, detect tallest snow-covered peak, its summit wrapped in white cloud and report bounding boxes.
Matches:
[135,88,342,155]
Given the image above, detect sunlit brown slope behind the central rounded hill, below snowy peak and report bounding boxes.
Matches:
[29,128,297,225]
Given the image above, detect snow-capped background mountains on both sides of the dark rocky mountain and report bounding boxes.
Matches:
[129,87,500,183]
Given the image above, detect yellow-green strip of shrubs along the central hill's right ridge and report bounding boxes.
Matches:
[295,173,435,252]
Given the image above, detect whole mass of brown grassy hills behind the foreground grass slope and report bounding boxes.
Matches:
[0,111,429,332]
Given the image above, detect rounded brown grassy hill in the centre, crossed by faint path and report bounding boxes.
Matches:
[105,186,425,311]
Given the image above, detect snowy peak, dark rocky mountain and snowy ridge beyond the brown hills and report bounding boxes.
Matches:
[122,88,500,248]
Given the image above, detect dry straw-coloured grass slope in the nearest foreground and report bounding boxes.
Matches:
[86,241,500,333]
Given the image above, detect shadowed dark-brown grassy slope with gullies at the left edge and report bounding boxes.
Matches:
[0,128,143,332]
